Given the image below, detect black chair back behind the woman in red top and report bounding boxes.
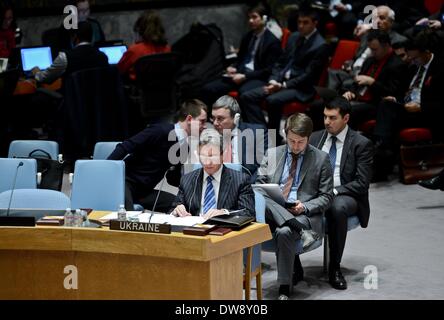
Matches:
[134,52,184,118]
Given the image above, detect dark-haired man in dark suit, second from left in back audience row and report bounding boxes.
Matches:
[240,10,328,129]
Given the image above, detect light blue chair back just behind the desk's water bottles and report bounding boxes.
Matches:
[71,160,125,211]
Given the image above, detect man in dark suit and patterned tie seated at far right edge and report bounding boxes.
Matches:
[374,30,444,149]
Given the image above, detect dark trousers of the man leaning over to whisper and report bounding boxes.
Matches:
[125,179,176,213]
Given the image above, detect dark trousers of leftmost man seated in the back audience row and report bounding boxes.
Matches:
[200,78,263,112]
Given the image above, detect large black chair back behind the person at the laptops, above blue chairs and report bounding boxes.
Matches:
[62,67,128,159]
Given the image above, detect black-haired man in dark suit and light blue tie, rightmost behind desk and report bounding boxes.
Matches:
[310,97,373,290]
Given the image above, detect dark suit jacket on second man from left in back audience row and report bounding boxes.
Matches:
[269,31,329,101]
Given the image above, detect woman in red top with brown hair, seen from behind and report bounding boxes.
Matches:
[117,10,171,80]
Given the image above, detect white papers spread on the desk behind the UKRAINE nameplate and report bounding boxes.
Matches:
[100,211,205,227]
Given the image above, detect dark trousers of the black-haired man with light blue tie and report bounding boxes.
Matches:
[325,195,358,270]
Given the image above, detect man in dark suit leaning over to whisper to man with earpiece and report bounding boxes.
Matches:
[108,99,207,212]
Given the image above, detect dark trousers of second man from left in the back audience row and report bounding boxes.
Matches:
[240,82,306,130]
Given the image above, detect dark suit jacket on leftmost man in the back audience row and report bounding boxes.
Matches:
[235,29,282,81]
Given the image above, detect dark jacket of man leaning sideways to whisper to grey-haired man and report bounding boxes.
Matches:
[108,123,177,192]
